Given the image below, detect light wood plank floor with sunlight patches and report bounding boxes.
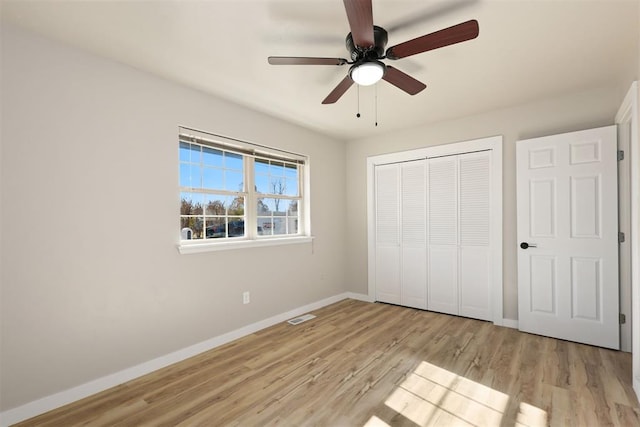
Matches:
[19,300,640,427]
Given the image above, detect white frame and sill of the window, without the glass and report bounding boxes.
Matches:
[177,126,313,254]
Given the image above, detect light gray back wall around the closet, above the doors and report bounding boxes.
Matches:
[346,81,630,319]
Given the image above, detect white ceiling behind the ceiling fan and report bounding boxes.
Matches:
[1,0,639,139]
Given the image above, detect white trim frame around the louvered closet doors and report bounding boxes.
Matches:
[367,135,504,326]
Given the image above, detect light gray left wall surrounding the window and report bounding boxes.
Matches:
[0,24,346,410]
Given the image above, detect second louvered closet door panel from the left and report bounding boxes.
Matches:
[400,160,427,309]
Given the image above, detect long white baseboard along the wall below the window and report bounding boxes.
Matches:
[0,292,360,427]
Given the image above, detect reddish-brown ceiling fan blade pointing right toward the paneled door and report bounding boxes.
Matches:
[386,19,479,59]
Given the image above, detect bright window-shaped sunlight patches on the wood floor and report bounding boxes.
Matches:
[365,361,547,427]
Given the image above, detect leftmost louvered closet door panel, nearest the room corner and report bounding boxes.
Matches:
[375,164,401,304]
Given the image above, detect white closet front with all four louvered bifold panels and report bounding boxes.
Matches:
[369,139,502,320]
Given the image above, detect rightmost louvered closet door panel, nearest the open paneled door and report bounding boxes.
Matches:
[458,151,491,320]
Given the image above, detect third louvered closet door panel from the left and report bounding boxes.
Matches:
[427,156,458,314]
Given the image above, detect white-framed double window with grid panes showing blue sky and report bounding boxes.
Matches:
[179,128,308,251]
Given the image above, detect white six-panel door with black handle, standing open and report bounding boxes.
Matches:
[516,126,620,349]
